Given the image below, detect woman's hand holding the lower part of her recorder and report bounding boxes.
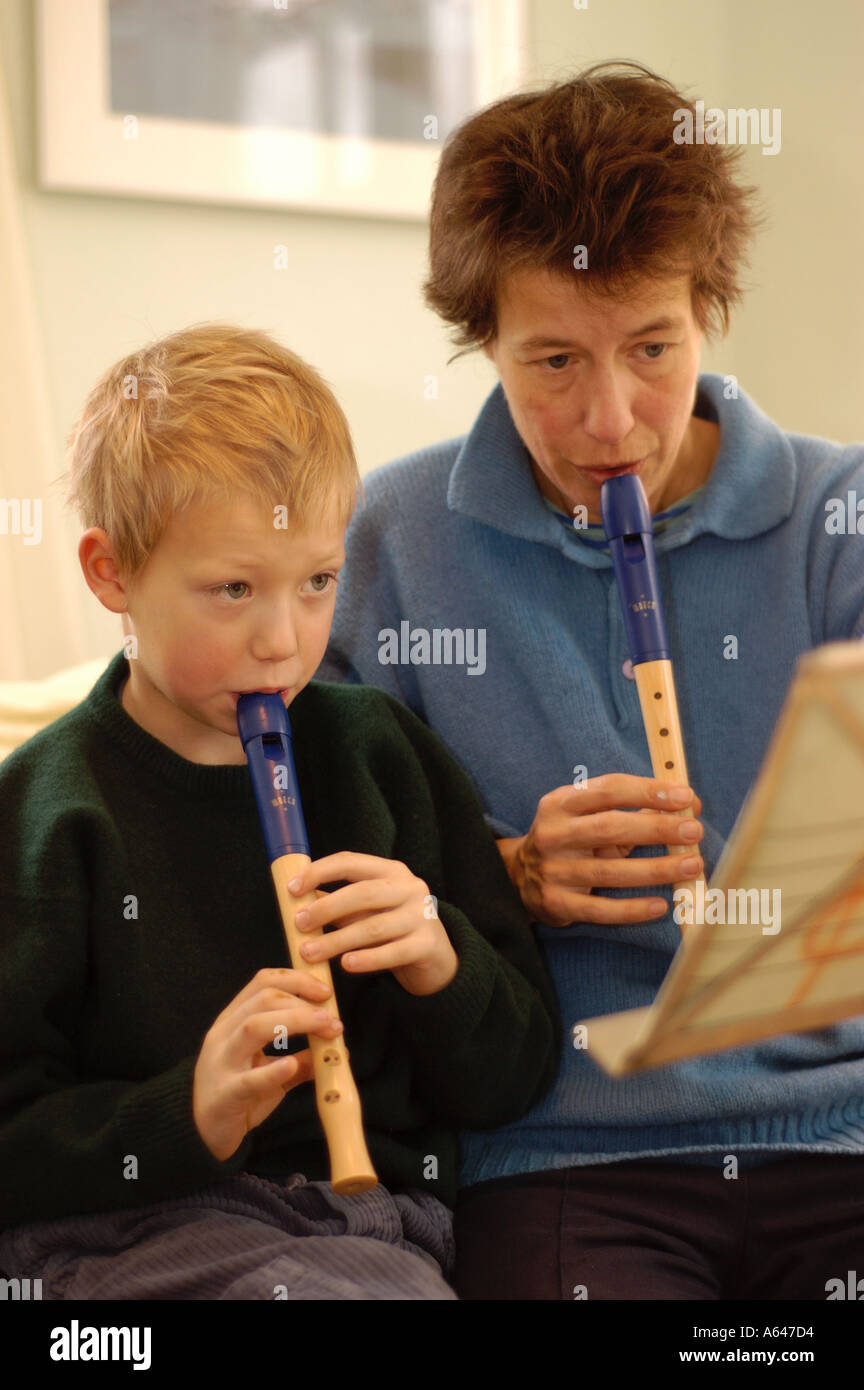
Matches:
[497,773,704,927]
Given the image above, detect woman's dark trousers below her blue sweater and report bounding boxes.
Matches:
[454,1154,864,1301]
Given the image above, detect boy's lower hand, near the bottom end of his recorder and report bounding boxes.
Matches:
[192,969,342,1161]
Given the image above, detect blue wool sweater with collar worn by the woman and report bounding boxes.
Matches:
[318,373,864,1186]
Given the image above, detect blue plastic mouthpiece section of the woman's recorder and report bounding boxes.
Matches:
[600,473,671,666]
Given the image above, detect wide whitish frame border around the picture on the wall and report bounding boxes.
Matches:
[36,0,526,220]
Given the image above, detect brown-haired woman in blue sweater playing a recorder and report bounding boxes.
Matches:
[318,64,864,1300]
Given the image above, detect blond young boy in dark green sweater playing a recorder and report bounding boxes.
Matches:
[0,324,561,1300]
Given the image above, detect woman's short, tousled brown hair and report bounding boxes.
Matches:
[424,63,764,360]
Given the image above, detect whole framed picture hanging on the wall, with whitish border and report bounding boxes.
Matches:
[36,0,526,218]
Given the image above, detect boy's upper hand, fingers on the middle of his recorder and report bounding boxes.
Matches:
[289,851,458,995]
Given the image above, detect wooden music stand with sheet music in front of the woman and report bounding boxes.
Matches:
[579,641,864,1076]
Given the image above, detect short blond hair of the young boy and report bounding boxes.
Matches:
[54,324,363,581]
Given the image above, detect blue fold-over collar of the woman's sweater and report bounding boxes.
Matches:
[447,373,797,569]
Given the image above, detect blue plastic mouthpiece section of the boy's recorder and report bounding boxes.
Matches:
[238,694,310,863]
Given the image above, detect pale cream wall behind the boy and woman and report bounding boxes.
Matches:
[0,0,864,680]
